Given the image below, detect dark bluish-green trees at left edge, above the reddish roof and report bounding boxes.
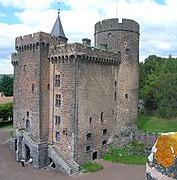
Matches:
[0,74,13,96]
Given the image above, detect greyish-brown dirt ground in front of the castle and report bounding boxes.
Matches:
[0,129,146,180]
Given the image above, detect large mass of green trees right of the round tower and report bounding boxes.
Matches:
[140,56,177,119]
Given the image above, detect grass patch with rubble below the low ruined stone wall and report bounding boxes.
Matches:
[102,142,148,164]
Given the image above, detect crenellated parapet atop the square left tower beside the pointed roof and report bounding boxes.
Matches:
[15,32,51,52]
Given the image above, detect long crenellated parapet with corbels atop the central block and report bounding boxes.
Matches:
[48,43,121,65]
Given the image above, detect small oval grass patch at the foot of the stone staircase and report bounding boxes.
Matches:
[82,162,103,173]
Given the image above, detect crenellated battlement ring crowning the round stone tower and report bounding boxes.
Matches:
[95,18,139,34]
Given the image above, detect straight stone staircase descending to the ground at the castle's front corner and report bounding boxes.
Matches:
[49,145,80,175]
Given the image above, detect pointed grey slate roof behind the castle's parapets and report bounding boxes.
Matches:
[51,13,66,38]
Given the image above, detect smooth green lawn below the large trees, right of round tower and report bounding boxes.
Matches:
[137,115,177,133]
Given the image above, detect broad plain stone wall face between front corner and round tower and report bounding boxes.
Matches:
[75,57,117,164]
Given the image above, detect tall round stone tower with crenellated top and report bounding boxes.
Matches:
[95,18,139,130]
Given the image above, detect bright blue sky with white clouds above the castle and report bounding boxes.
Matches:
[0,0,177,74]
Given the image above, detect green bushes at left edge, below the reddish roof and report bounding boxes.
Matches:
[0,102,13,121]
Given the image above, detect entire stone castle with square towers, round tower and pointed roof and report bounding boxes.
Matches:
[12,11,139,175]
